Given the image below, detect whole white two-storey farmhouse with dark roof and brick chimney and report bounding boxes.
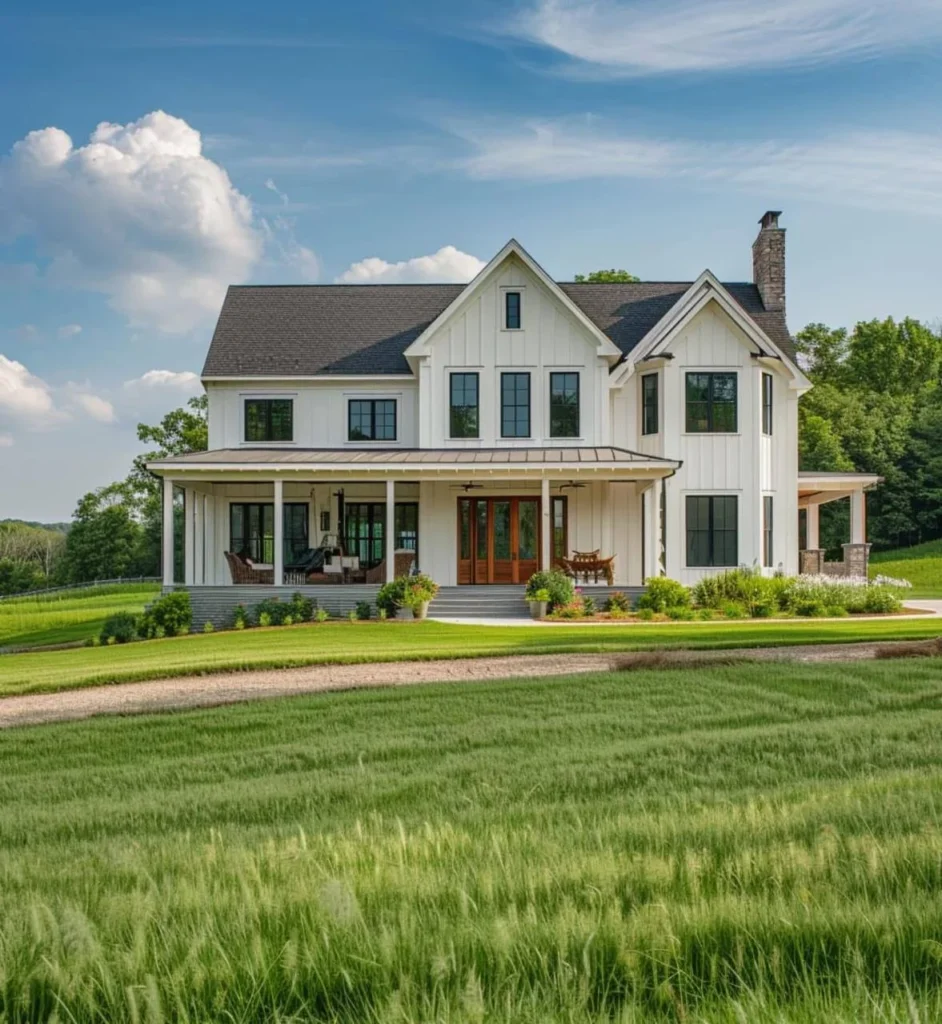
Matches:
[149,211,876,617]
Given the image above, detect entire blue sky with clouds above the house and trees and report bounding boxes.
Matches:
[0,0,942,520]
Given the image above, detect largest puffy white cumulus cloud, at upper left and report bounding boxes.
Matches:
[0,111,263,331]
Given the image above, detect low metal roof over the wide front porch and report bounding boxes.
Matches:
[147,446,681,476]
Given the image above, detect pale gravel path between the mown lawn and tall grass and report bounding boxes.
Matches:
[0,642,937,729]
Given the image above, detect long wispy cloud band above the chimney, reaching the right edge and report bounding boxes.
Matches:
[448,118,942,216]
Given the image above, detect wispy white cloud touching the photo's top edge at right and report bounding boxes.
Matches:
[507,0,942,76]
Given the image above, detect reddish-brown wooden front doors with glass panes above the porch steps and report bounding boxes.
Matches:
[458,498,541,584]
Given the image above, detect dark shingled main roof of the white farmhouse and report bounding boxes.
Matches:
[203,282,795,377]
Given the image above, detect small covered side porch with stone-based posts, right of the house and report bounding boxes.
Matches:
[798,471,883,577]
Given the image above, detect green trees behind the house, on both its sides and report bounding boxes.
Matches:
[0,315,942,594]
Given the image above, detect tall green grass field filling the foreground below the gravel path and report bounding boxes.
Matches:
[0,660,942,1024]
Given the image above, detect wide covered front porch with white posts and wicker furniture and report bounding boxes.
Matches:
[151,449,677,588]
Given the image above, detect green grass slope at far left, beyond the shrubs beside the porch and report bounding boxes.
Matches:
[0,584,160,647]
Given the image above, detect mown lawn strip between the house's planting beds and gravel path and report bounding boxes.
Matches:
[0,617,942,696]
